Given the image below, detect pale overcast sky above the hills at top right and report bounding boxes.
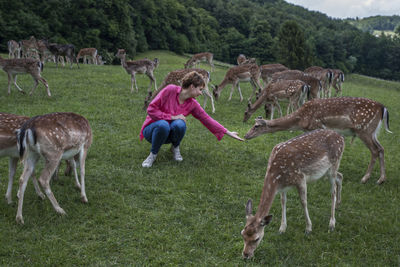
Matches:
[286,0,400,18]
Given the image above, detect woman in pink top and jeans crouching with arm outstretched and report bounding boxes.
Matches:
[140,71,243,167]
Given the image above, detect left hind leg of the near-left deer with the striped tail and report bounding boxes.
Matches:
[15,152,39,224]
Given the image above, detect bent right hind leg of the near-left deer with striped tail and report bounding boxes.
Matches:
[39,156,66,215]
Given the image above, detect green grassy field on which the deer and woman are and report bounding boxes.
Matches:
[0,51,400,266]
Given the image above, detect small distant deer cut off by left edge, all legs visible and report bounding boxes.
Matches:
[0,56,51,97]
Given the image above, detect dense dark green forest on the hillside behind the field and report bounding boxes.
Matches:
[0,0,400,80]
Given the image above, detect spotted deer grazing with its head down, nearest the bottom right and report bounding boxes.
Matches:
[241,129,345,259]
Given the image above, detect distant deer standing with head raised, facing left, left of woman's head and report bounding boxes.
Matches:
[115,49,159,93]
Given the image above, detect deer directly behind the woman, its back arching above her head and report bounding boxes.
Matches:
[143,69,215,113]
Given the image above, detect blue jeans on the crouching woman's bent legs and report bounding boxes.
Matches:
[143,120,186,154]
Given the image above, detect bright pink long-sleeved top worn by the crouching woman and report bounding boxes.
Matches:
[140,84,228,140]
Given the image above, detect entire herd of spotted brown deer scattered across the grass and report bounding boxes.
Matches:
[0,43,390,258]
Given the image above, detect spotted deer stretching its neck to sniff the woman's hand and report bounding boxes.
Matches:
[244,97,391,184]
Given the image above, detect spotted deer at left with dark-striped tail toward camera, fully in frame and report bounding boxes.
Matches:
[16,112,92,224]
